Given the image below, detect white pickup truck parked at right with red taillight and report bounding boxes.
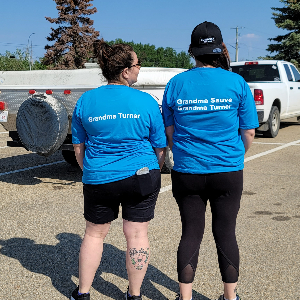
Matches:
[231,60,300,137]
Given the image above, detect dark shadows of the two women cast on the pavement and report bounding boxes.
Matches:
[0,233,209,300]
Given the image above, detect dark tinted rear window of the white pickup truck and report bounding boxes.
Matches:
[231,65,280,82]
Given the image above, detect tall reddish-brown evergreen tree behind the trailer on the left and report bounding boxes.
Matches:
[43,0,99,69]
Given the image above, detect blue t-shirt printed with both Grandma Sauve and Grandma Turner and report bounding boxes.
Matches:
[162,68,259,174]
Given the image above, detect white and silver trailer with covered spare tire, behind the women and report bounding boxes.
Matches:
[0,64,185,171]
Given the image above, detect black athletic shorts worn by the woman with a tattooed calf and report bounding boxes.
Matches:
[83,170,161,224]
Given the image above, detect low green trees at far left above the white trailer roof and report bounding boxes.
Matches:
[0,49,46,71]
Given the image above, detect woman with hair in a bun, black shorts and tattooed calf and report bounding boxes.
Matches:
[71,39,167,300]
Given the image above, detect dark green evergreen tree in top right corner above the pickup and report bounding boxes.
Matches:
[266,0,300,67]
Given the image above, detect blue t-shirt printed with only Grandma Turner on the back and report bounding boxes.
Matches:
[72,85,167,184]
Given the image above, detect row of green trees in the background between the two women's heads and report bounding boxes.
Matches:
[108,39,194,69]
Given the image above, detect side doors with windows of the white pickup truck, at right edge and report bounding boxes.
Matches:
[284,64,300,114]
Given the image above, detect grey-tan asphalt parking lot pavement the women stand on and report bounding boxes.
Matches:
[0,119,300,300]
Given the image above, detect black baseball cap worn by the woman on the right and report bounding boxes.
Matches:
[190,21,223,56]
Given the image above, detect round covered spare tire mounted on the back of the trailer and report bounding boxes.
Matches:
[16,94,69,156]
